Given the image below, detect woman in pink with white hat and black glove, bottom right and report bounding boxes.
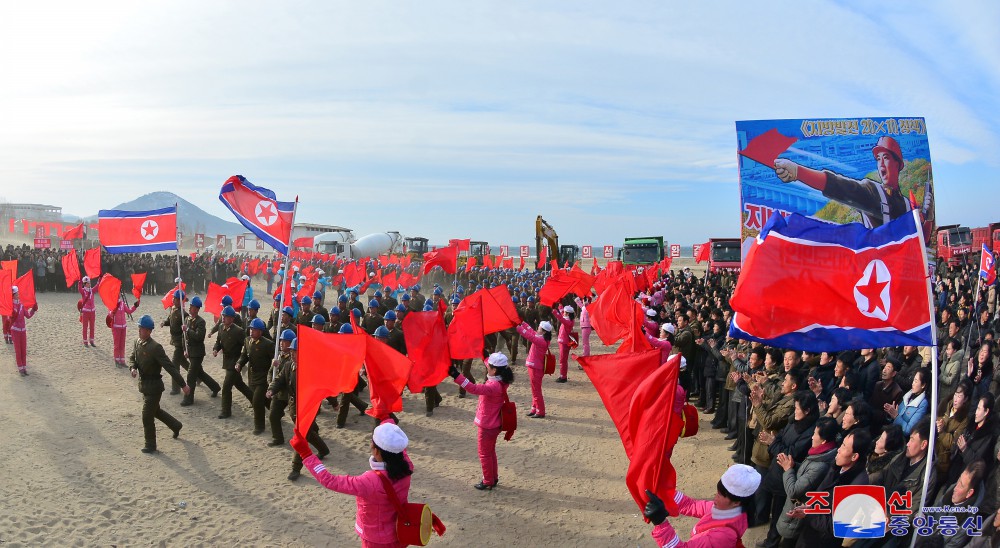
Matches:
[643,464,760,548]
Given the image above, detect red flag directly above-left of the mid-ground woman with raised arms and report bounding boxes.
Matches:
[403,312,451,392]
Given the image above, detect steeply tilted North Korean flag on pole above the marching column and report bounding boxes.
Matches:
[219,175,298,255]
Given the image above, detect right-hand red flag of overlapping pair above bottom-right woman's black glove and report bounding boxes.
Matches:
[625,351,682,515]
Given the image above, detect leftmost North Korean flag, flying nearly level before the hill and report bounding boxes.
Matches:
[97,206,177,254]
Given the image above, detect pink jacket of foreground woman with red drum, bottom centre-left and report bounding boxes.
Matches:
[302,455,410,544]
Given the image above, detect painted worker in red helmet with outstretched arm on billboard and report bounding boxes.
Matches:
[774,136,912,228]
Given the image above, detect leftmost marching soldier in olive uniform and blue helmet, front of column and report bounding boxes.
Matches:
[128,315,190,453]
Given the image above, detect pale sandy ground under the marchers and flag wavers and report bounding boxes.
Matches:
[0,293,764,547]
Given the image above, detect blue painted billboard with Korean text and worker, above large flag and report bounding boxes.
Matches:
[736,118,934,258]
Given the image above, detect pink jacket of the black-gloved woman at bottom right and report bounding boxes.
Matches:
[652,492,747,548]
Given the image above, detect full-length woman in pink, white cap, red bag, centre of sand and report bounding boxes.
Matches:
[448,352,514,491]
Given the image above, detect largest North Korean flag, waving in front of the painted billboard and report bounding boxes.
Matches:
[729,212,933,352]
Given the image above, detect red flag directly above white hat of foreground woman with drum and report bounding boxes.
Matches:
[364,333,413,419]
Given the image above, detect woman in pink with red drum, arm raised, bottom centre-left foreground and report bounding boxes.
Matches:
[291,419,413,548]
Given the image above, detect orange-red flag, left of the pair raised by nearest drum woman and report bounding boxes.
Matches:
[295,329,366,438]
